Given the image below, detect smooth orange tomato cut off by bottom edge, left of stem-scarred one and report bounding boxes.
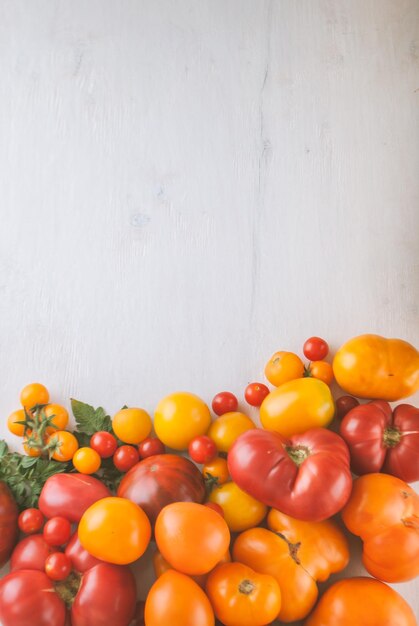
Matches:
[145,569,215,626]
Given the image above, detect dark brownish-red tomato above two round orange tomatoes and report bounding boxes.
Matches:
[118,454,205,524]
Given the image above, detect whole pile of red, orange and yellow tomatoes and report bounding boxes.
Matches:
[0,335,419,626]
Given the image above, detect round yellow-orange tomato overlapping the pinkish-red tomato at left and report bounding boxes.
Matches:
[78,497,151,565]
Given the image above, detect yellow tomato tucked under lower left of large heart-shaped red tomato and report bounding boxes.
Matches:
[209,482,268,532]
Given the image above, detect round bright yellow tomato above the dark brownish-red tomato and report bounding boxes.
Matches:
[154,391,211,450]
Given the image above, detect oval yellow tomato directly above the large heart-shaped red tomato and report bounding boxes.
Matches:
[260,378,335,437]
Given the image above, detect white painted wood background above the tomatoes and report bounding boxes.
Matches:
[0,0,419,615]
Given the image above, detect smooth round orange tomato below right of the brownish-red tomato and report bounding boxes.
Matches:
[154,502,230,575]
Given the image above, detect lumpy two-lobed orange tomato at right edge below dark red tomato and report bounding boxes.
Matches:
[342,474,419,583]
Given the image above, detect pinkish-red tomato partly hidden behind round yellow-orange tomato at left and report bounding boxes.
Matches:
[38,473,111,522]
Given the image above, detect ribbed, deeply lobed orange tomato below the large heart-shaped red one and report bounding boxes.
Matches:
[233,509,349,623]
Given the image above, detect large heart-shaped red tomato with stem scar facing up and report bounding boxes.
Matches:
[228,428,352,522]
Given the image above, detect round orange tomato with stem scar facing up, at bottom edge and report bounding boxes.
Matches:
[206,563,281,626]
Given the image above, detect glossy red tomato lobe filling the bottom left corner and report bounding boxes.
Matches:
[0,570,66,626]
